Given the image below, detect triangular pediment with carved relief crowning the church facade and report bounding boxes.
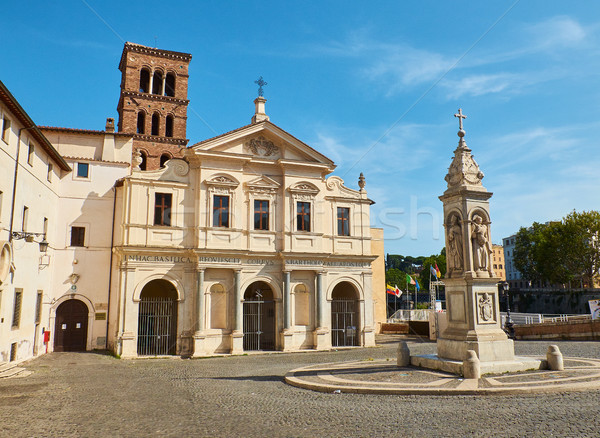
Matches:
[186,121,335,170]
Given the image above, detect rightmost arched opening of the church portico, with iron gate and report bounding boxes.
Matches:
[331,281,360,347]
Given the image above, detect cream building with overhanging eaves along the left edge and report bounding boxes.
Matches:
[0,78,71,365]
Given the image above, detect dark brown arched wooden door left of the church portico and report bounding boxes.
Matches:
[54,299,88,351]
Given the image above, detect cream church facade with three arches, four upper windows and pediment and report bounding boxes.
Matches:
[109,97,377,357]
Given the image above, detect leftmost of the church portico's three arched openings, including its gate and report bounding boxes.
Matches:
[137,280,177,356]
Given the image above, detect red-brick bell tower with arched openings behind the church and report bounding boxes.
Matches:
[117,42,192,170]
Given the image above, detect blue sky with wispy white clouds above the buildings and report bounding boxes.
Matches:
[0,0,600,255]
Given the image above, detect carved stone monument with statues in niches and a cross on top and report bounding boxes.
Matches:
[411,109,540,374]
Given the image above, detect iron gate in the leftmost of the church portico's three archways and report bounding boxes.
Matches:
[138,297,177,356]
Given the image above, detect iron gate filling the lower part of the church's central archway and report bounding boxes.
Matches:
[244,299,275,351]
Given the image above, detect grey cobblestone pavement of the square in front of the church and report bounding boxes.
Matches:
[0,341,600,437]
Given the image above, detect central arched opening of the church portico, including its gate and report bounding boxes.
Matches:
[244,281,275,351]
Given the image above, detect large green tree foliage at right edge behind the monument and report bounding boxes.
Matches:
[513,211,600,285]
